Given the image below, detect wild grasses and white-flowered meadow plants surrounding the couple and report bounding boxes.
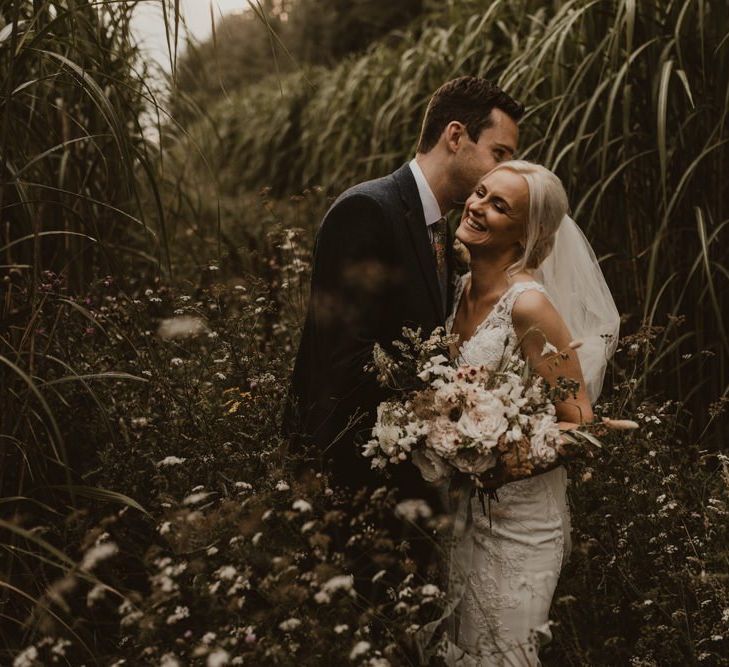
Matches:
[0,0,729,667]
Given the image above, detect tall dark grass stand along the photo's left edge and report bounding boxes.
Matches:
[0,0,173,661]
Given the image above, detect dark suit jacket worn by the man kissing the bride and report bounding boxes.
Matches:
[284,164,453,502]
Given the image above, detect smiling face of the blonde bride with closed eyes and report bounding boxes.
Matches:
[456,169,529,250]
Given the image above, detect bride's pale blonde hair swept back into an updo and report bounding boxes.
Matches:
[489,160,569,273]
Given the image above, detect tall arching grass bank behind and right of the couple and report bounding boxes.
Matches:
[176,0,729,444]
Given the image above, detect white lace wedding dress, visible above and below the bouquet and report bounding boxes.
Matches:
[438,275,570,667]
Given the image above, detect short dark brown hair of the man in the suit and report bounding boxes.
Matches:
[418,76,524,153]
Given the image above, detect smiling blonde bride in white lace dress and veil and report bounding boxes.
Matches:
[436,161,619,666]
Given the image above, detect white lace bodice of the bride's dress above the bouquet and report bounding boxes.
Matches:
[446,273,547,368]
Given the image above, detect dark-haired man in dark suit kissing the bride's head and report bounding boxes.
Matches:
[284,76,524,509]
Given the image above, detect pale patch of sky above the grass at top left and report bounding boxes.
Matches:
[132,0,248,71]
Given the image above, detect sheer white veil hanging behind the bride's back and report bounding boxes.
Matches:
[536,215,620,403]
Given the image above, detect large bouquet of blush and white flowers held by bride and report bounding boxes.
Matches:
[363,329,599,487]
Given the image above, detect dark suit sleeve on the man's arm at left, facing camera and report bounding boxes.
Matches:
[311,194,394,407]
